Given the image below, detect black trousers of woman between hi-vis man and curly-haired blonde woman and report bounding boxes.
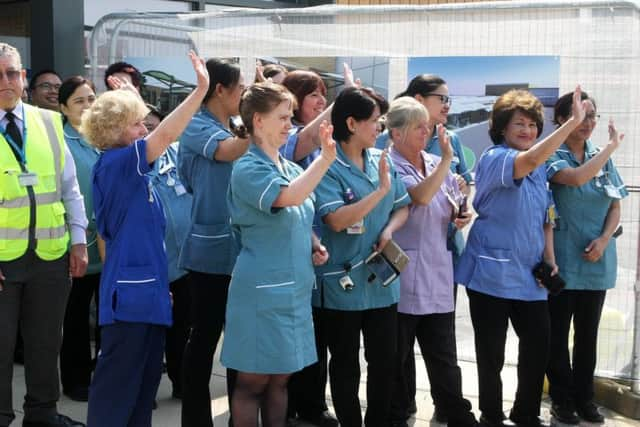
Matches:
[60,273,100,392]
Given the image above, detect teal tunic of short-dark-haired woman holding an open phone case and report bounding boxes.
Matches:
[313,144,411,311]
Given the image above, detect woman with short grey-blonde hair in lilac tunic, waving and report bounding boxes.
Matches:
[386,97,476,426]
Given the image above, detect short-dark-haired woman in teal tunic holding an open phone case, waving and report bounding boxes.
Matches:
[313,88,410,426]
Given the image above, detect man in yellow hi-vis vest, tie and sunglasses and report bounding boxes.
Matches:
[0,42,87,427]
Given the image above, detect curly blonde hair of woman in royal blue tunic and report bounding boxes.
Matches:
[80,90,149,150]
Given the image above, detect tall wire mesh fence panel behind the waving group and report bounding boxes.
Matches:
[89,1,640,380]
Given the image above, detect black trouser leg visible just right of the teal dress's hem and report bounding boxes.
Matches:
[287,307,328,418]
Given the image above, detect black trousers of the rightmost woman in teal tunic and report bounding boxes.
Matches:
[547,290,606,405]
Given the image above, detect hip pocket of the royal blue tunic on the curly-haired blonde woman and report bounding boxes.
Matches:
[111,266,159,322]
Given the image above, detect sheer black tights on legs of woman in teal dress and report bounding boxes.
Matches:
[231,372,291,427]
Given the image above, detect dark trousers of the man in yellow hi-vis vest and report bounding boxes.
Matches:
[0,251,71,425]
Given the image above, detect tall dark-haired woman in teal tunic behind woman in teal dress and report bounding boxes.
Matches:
[178,58,249,427]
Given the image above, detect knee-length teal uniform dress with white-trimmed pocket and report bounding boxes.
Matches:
[221,144,317,374]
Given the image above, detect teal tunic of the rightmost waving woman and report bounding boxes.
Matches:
[547,141,629,291]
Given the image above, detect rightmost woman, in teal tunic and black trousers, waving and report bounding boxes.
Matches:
[547,92,628,424]
